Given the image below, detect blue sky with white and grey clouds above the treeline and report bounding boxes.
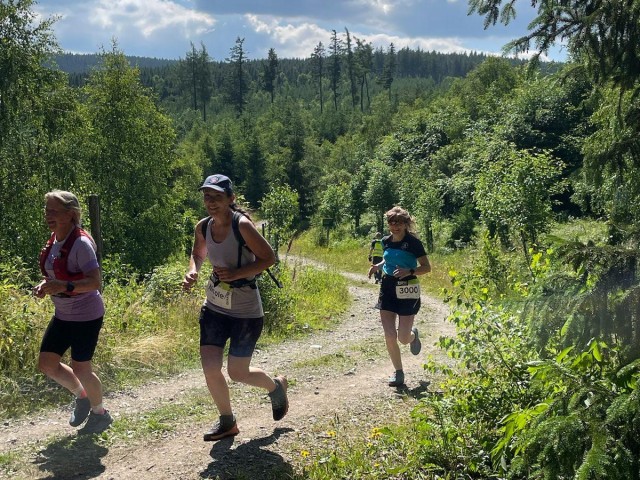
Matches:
[34,0,566,61]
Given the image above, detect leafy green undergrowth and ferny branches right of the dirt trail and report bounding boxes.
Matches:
[296,218,640,480]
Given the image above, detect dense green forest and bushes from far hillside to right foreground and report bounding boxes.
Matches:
[0,0,640,479]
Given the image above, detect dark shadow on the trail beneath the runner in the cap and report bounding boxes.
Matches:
[200,428,293,480]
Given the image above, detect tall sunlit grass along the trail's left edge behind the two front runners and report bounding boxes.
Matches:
[0,255,349,419]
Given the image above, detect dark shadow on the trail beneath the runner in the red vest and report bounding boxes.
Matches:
[33,435,109,480]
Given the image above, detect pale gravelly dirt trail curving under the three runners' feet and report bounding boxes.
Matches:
[0,262,453,480]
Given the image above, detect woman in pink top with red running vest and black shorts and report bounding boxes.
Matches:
[33,190,113,433]
